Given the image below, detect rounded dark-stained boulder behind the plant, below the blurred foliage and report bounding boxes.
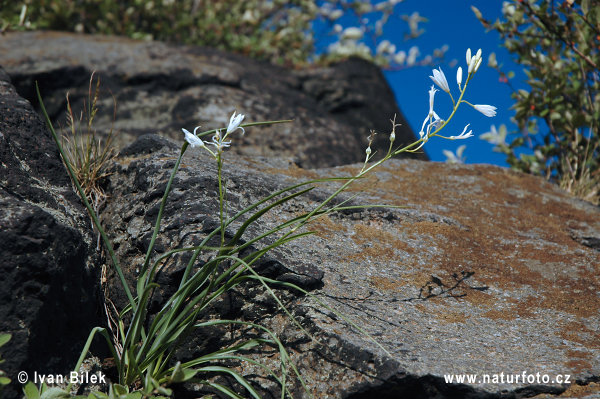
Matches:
[0,32,426,168]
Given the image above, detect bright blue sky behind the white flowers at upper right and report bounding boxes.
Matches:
[316,0,524,166]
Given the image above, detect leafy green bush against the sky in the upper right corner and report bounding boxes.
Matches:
[474,0,600,203]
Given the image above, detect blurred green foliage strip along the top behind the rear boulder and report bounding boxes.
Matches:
[0,0,446,67]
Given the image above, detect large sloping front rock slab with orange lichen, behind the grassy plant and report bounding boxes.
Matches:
[103,136,600,399]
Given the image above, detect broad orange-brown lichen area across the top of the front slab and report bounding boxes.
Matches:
[282,163,600,326]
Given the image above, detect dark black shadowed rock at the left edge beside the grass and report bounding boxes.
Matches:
[0,68,102,398]
